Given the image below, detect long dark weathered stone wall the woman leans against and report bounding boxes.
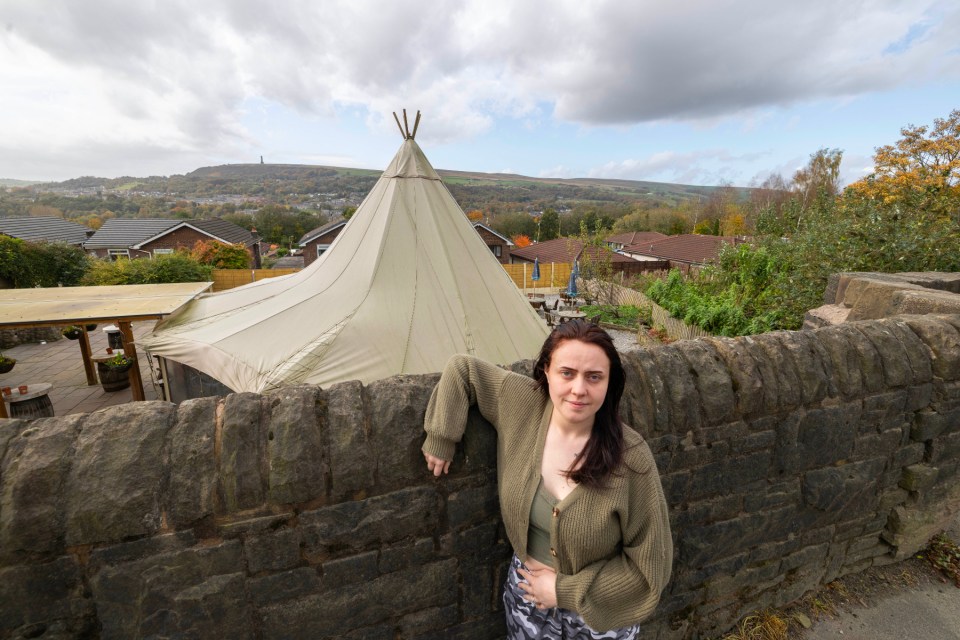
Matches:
[0,316,960,640]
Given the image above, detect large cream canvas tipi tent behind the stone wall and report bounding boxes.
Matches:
[141,125,547,392]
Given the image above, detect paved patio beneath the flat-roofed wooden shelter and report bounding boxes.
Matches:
[0,321,163,416]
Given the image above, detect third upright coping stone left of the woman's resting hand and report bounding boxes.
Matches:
[267,387,326,504]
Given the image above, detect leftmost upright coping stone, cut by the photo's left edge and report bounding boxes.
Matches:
[0,416,83,564]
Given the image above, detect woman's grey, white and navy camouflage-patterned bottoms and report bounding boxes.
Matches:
[503,554,640,640]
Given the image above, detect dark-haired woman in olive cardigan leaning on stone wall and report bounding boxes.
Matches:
[423,320,673,638]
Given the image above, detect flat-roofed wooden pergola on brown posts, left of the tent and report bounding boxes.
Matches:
[0,282,213,418]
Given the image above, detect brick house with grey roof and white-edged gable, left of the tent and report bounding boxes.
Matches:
[83,218,260,267]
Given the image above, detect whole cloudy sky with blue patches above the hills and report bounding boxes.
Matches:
[0,0,960,185]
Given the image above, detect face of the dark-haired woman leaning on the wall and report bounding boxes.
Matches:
[545,340,610,429]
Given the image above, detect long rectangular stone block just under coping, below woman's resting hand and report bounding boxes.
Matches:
[300,487,440,556]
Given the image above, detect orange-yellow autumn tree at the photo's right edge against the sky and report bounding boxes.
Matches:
[848,109,960,222]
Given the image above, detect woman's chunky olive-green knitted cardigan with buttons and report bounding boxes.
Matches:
[423,355,673,631]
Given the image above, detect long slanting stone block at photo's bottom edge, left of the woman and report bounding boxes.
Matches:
[260,559,458,640]
